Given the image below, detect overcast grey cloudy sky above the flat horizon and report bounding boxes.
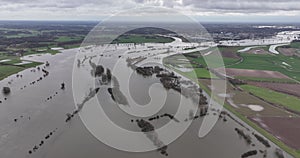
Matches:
[0,0,300,22]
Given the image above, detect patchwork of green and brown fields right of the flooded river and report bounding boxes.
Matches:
[167,46,300,157]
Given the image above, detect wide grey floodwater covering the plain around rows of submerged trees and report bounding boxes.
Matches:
[0,43,289,158]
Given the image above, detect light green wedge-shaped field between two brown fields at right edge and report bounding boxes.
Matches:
[241,85,300,112]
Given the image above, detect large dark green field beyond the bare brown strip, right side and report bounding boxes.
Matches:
[186,47,300,82]
